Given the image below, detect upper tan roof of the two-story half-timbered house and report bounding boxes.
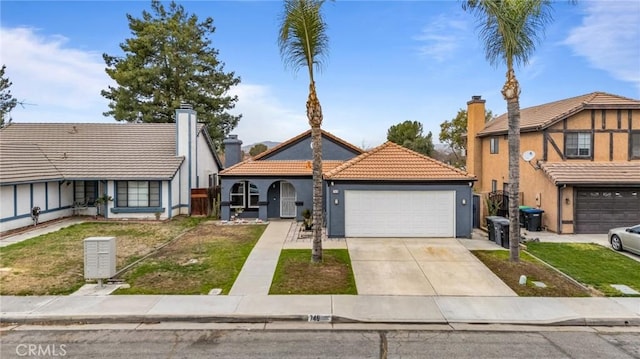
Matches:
[478,92,640,136]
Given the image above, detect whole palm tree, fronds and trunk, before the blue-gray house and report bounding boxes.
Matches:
[278,0,329,263]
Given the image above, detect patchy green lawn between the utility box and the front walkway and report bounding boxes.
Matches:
[114,224,266,294]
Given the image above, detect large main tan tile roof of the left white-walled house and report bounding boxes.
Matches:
[0,123,184,183]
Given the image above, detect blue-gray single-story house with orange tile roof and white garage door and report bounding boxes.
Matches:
[220,131,475,237]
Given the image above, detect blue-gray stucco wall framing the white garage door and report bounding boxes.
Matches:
[325,181,473,238]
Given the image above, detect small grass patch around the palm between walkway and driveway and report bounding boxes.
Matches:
[269,249,358,294]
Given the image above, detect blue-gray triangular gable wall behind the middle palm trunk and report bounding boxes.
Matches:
[261,137,360,161]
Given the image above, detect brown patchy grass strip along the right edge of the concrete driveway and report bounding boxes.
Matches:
[472,251,594,297]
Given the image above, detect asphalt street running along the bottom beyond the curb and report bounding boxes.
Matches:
[0,324,640,359]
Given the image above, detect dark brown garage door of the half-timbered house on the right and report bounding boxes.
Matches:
[575,188,640,233]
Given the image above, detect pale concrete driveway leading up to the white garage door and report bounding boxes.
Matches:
[347,238,517,296]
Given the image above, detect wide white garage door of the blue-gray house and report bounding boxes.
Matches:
[344,191,456,237]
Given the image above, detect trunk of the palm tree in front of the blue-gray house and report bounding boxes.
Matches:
[307,81,324,263]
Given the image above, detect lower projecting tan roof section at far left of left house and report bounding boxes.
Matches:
[0,142,64,183]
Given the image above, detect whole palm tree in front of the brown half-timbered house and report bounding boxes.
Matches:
[462,0,552,262]
